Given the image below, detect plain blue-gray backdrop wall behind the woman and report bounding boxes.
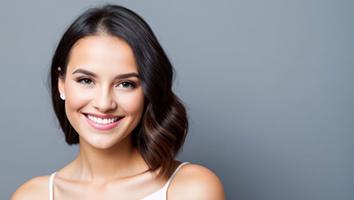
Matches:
[0,0,354,200]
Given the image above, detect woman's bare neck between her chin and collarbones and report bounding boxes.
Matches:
[73,138,148,182]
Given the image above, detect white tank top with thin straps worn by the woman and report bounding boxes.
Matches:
[49,162,189,200]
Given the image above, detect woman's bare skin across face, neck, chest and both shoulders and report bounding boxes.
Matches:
[11,33,225,200]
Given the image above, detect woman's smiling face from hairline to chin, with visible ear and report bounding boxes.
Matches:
[58,35,144,149]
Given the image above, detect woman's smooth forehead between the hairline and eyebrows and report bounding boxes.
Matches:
[67,35,138,74]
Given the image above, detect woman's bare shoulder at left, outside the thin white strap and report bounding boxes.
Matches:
[11,176,49,200]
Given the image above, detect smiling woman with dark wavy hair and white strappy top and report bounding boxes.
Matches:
[12,5,224,200]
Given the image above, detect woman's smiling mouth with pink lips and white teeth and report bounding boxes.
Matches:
[84,114,124,131]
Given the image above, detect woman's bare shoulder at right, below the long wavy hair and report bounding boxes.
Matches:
[168,164,225,200]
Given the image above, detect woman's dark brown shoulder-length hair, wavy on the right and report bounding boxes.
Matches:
[50,4,188,177]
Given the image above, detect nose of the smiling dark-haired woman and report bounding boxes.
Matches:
[94,86,117,113]
